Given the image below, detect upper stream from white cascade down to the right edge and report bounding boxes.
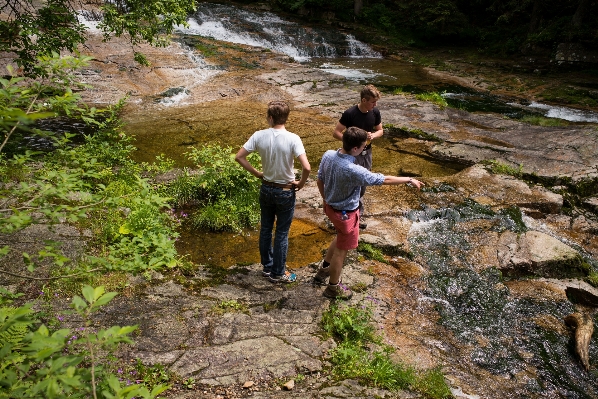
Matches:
[178,3,598,122]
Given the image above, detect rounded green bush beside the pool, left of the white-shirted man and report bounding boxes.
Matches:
[165,145,260,231]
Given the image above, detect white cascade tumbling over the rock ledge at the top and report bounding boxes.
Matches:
[179,3,381,62]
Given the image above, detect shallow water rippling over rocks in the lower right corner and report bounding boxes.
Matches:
[408,201,598,399]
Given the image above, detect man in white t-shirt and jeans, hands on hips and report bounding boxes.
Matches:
[235,101,311,283]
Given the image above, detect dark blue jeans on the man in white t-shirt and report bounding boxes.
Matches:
[260,185,295,276]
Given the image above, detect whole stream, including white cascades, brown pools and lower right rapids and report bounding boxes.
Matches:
[77,3,598,399]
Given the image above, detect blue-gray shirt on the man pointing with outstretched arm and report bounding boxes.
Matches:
[318,150,384,211]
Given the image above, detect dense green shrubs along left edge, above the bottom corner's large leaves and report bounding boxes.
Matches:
[0,55,178,280]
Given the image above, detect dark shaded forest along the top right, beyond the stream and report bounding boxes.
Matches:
[242,0,598,55]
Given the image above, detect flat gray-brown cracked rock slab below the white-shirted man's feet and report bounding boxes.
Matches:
[92,264,374,386]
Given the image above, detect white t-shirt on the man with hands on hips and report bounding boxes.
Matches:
[243,128,305,184]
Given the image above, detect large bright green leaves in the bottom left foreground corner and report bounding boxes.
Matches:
[0,286,168,399]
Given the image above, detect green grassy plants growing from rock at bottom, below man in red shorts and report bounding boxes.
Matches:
[322,304,451,399]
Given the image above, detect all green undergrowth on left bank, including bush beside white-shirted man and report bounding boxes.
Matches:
[0,54,259,398]
